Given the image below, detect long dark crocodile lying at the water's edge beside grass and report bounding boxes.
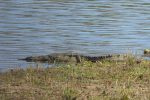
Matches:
[19,53,120,63]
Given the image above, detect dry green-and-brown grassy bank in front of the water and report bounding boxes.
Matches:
[0,56,150,100]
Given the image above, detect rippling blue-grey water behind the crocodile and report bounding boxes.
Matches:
[0,0,150,69]
